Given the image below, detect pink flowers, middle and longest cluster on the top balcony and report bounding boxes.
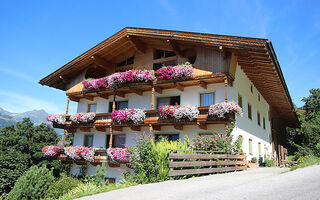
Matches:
[107,70,156,90]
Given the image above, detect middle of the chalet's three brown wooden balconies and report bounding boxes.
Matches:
[53,107,235,132]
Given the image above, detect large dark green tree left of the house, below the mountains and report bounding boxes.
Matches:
[0,119,69,193]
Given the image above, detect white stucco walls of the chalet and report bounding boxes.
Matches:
[72,66,271,181]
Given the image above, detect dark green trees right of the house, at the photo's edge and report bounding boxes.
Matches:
[287,88,320,158]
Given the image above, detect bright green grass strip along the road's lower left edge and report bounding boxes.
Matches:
[59,182,137,200]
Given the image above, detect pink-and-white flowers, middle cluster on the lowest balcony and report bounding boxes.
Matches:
[64,146,94,162]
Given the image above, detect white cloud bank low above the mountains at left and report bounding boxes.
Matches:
[0,89,64,113]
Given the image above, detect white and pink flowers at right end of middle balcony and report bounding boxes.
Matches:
[208,101,242,118]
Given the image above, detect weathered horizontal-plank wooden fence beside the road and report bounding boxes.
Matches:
[169,150,247,176]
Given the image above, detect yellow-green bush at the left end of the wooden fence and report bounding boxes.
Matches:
[153,139,190,181]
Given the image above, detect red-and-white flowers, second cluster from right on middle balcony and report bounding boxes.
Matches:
[159,105,200,121]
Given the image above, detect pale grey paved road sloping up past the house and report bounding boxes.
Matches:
[77,165,320,200]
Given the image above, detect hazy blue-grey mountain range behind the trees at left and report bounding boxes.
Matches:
[0,108,48,129]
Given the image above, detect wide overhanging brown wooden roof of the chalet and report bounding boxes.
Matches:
[39,27,299,127]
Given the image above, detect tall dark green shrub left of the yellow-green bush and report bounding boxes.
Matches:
[128,132,159,184]
